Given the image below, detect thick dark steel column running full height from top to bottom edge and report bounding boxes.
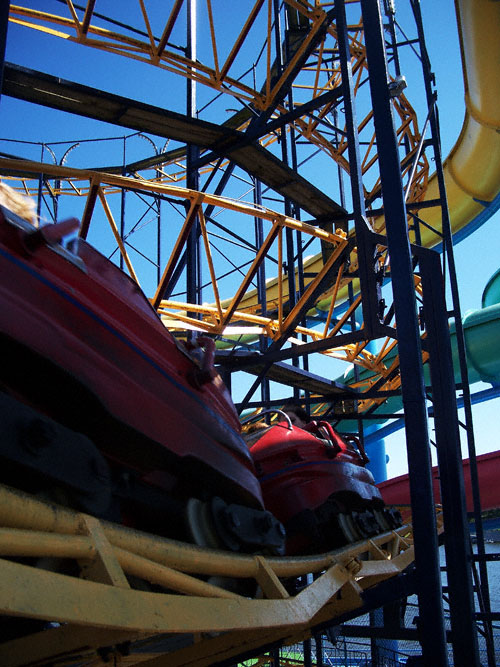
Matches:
[361,0,448,667]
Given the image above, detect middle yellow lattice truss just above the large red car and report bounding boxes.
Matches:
[0,151,426,418]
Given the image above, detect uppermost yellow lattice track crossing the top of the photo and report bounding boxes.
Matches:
[11,0,428,209]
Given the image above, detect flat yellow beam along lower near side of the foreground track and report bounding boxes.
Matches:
[0,560,350,633]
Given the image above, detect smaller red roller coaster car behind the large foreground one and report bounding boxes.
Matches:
[247,413,401,554]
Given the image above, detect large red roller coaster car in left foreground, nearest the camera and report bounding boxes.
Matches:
[0,206,284,553]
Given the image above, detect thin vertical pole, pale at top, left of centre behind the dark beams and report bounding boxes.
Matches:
[186,0,201,324]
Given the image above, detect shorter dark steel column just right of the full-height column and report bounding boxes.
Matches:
[419,250,479,667]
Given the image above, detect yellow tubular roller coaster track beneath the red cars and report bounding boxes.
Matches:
[0,486,441,667]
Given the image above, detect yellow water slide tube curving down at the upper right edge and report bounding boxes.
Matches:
[420,0,500,247]
